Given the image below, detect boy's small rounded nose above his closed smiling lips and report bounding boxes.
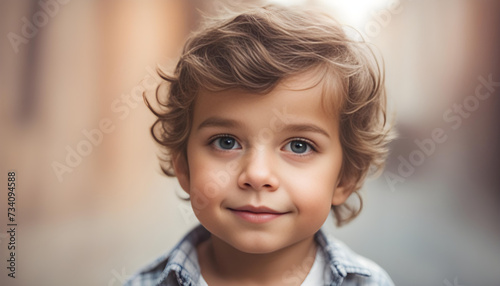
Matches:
[238,147,279,191]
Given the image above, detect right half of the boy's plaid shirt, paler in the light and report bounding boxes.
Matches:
[316,231,394,286]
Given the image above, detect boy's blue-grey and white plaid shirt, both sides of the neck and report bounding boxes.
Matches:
[125,225,394,286]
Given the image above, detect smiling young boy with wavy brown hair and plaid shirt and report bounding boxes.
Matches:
[126,2,393,286]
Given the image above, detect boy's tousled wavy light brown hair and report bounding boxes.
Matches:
[146,5,391,226]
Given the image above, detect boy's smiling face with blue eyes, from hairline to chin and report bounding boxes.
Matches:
[174,74,350,253]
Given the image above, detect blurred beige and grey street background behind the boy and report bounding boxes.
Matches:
[0,0,500,286]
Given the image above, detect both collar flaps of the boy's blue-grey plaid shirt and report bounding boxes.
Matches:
[158,225,372,286]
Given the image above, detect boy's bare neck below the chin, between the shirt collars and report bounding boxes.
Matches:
[198,235,316,285]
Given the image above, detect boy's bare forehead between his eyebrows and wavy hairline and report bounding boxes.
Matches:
[193,68,340,132]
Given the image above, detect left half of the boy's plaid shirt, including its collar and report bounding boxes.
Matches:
[124,226,210,286]
